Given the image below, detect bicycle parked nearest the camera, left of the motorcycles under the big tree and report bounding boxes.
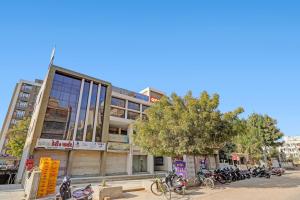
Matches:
[150,178,171,200]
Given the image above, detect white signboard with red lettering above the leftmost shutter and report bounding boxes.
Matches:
[35,138,73,150]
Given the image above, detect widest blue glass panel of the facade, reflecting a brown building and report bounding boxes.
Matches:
[41,73,81,139]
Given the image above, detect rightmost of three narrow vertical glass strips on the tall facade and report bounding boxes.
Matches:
[95,85,107,142]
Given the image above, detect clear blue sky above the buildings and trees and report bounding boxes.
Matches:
[0,0,300,135]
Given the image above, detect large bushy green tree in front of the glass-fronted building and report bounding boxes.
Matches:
[133,92,243,157]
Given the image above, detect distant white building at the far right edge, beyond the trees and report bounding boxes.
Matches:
[279,136,300,159]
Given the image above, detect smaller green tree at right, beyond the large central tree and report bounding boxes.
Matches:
[234,113,283,161]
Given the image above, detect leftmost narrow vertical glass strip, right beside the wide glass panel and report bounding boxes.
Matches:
[75,81,91,141]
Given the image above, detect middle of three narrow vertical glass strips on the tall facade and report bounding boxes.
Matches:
[85,84,98,142]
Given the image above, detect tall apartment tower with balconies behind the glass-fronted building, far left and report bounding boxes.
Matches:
[0,79,43,154]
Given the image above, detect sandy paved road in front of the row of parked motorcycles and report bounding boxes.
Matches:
[124,171,300,200]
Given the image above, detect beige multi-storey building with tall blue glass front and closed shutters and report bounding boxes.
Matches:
[17,65,172,181]
